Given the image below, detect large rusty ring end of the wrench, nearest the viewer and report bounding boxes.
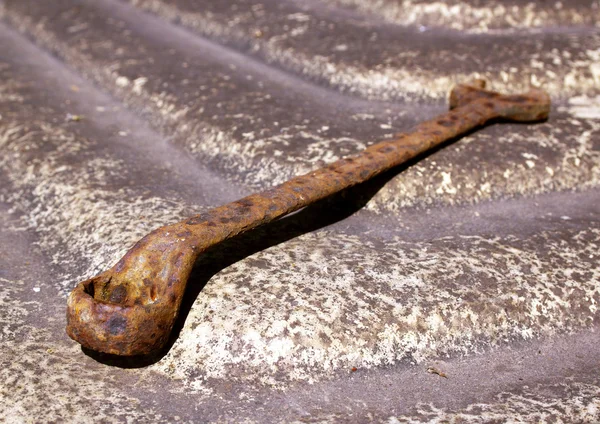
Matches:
[67,234,195,356]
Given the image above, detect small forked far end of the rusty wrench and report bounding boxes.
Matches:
[450,80,551,122]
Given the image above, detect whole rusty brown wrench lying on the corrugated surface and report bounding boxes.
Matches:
[67,81,550,355]
